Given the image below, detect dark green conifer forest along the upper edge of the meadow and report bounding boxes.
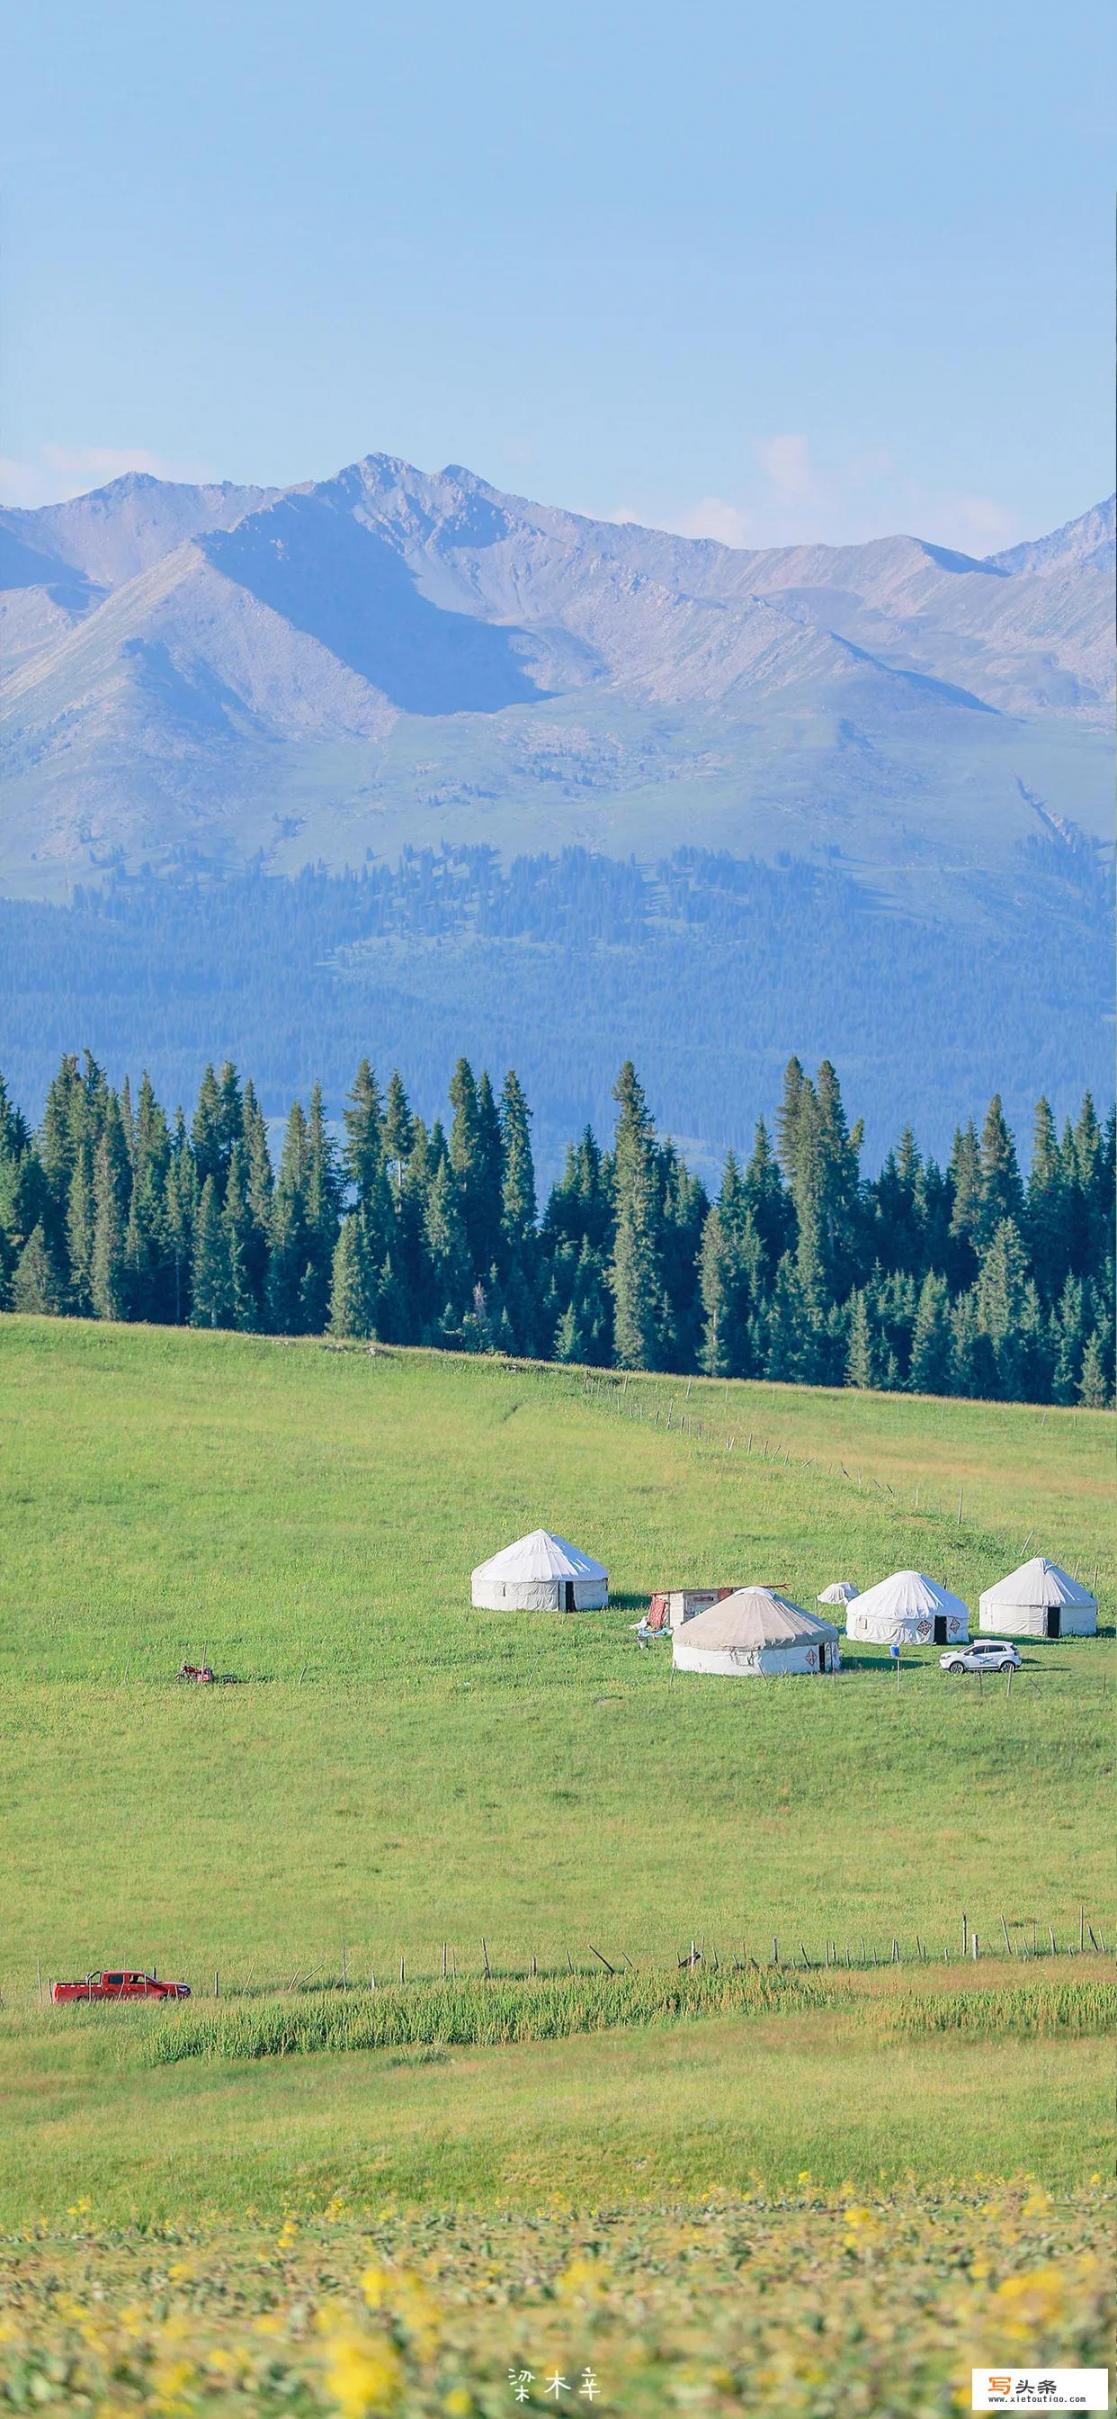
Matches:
[0,1055,1115,1408]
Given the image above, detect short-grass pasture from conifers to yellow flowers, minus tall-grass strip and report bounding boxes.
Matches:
[0,1318,1115,2221]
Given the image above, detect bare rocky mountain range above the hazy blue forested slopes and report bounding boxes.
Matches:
[0,455,1115,897]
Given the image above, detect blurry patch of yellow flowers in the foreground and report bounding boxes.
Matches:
[0,2175,1112,2419]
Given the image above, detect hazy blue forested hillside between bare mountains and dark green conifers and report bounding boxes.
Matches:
[0,820,1112,1185]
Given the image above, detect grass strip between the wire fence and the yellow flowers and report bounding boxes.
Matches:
[0,1959,1112,2228]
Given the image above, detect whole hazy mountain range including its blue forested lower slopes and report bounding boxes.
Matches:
[0,455,1115,1166]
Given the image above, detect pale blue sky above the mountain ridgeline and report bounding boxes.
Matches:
[0,0,1117,554]
